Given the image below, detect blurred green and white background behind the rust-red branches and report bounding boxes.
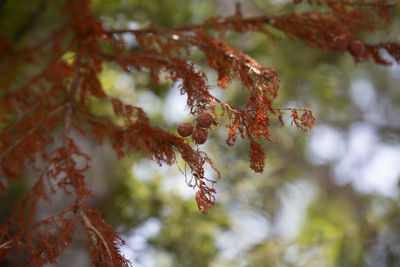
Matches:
[0,0,400,267]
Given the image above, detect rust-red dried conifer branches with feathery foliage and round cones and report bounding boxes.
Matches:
[0,0,400,266]
